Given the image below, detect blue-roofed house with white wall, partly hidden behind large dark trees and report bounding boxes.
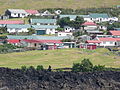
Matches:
[59,15,92,22]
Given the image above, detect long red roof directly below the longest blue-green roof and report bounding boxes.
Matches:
[23,39,62,43]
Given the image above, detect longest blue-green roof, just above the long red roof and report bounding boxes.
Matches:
[7,35,73,40]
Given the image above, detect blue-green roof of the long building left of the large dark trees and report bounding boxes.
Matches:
[31,19,57,24]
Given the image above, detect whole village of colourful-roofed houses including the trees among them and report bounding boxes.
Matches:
[0,9,120,50]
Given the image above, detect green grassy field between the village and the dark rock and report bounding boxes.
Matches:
[0,49,120,68]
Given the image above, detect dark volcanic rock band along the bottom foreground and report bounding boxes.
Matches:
[0,68,120,90]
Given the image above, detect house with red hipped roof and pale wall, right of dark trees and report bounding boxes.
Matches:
[82,22,98,30]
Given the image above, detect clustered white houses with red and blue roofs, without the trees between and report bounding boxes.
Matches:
[0,9,120,50]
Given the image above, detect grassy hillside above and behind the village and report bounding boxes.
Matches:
[0,0,120,13]
